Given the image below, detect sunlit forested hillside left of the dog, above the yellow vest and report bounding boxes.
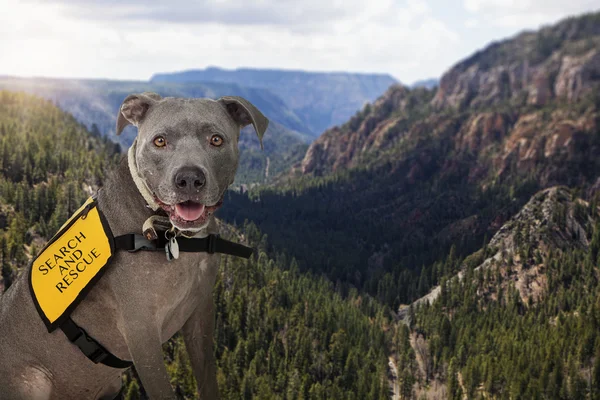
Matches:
[0,91,119,288]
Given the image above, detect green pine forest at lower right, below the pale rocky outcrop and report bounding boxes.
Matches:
[394,217,600,399]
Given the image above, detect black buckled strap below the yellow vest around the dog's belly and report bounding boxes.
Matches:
[60,317,133,369]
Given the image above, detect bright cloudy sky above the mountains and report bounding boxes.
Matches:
[0,0,600,83]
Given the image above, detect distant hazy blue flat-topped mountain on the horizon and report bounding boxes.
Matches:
[151,67,397,137]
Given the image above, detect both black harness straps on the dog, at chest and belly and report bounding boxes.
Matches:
[60,232,253,368]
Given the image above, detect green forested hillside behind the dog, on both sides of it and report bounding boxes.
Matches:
[0,91,390,400]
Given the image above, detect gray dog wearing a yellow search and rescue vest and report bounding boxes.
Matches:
[0,93,268,400]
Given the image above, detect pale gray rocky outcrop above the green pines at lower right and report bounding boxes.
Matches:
[398,187,600,319]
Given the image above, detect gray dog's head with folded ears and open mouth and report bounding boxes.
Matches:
[117,93,269,231]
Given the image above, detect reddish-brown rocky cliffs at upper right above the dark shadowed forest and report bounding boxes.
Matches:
[300,13,600,186]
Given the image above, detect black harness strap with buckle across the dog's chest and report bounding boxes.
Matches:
[115,233,253,258]
